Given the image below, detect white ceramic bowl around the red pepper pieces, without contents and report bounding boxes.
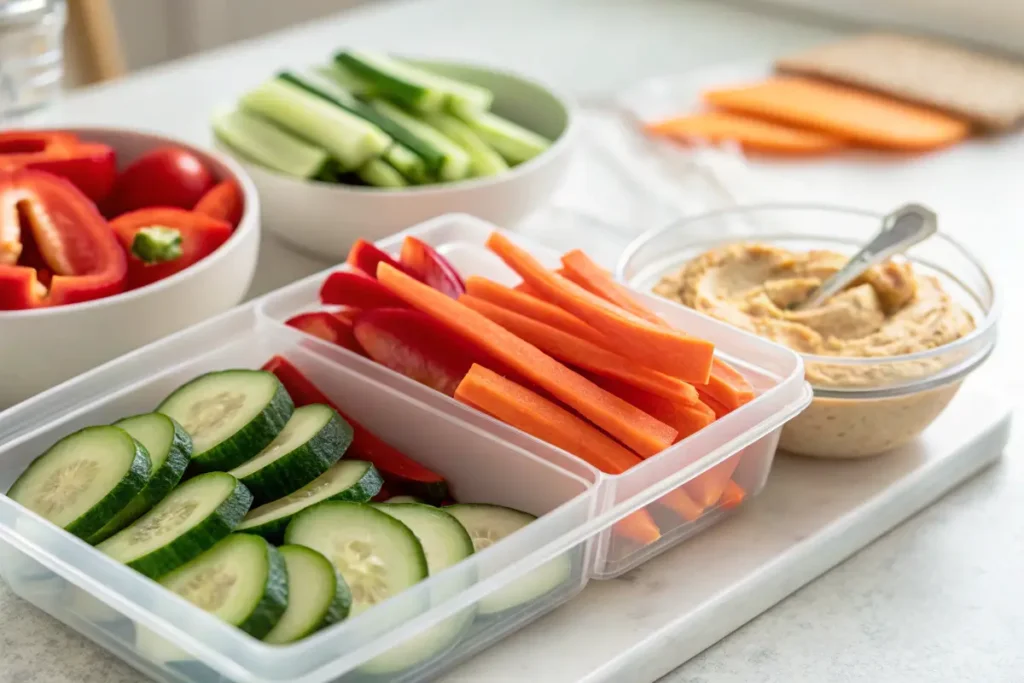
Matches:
[0,128,260,410]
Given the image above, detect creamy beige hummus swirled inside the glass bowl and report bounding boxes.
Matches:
[654,244,974,387]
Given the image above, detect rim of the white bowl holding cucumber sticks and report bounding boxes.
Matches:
[221,56,579,199]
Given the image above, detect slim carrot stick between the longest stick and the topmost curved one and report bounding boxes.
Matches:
[459,294,699,403]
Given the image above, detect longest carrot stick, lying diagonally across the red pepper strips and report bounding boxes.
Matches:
[377,263,676,457]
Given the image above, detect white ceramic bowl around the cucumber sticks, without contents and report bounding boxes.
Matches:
[220,61,574,261]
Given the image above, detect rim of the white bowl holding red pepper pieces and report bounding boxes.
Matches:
[0,126,260,324]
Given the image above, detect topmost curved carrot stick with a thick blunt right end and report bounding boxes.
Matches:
[487,232,715,384]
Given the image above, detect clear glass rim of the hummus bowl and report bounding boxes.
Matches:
[614,202,1002,398]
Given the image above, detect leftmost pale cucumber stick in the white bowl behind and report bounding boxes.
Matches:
[213,105,331,178]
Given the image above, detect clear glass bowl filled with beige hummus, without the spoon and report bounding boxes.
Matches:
[615,204,999,458]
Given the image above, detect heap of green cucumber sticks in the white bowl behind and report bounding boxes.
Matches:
[213,50,551,187]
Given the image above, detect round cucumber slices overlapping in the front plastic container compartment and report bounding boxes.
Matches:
[2,362,570,673]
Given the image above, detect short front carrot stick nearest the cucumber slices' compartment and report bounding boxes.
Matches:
[455,365,660,545]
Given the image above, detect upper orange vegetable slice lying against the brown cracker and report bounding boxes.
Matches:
[703,76,971,151]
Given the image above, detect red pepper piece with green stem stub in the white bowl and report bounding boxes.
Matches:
[111,208,232,289]
